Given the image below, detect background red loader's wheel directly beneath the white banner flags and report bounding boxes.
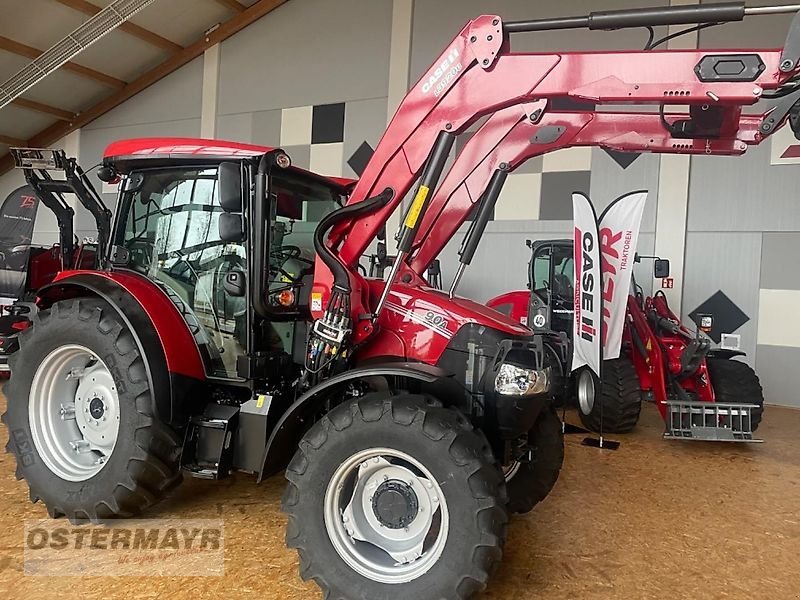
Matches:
[575,357,642,433]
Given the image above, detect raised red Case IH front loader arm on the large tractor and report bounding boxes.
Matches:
[309,3,800,380]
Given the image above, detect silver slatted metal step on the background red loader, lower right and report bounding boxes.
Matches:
[664,400,764,442]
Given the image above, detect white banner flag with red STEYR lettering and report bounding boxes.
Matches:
[600,191,647,360]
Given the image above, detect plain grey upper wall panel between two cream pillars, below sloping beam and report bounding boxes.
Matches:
[217,0,392,114]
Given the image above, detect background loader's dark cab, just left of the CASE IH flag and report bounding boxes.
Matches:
[527,239,575,337]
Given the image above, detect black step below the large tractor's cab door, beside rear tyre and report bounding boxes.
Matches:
[181,404,239,479]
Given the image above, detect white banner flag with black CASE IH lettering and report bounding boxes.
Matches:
[572,192,602,377]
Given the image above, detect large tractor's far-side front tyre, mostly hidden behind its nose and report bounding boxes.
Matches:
[505,406,564,514]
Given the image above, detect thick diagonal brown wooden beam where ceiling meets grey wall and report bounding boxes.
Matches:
[0,0,287,175]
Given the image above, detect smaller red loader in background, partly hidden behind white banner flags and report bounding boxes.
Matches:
[487,239,764,441]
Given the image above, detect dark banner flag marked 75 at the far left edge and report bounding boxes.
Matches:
[0,185,39,298]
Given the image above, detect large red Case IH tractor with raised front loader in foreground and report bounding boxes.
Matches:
[4,3,800,600]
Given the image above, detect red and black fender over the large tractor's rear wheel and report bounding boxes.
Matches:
[37,271,205,425]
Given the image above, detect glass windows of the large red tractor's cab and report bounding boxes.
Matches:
[115,166,340,378]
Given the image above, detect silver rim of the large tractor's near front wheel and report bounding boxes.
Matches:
[324,448,450,584]
